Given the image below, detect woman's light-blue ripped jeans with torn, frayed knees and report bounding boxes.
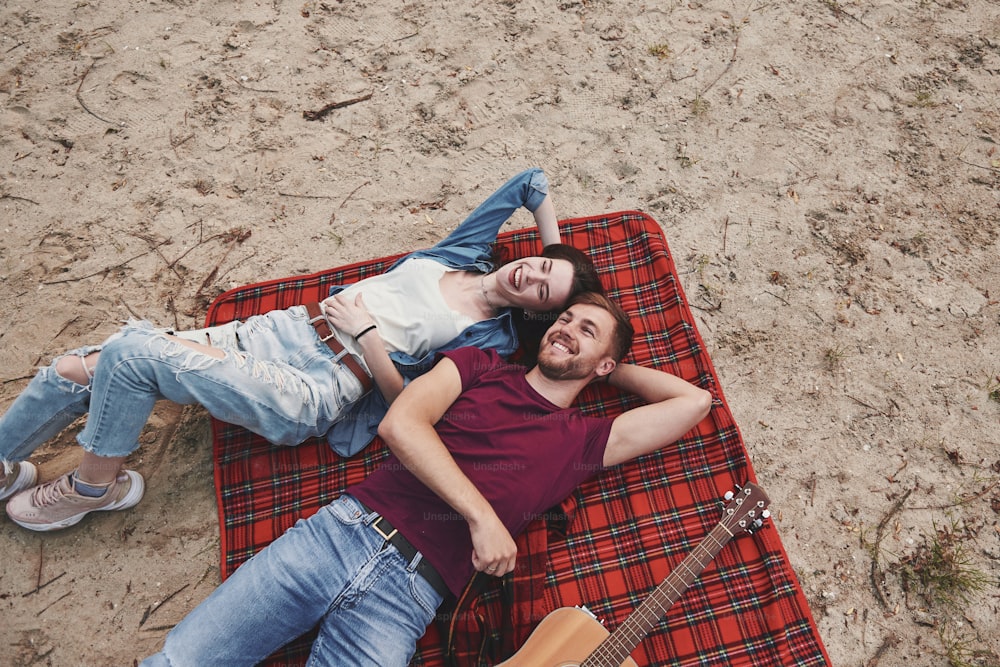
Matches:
[0,306,363,463]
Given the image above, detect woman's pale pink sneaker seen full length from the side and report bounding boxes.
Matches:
[7,470,146,531]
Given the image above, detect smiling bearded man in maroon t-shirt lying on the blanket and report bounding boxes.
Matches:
[143,293,711,667]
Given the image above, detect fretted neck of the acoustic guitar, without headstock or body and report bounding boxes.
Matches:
[580,523,733,667]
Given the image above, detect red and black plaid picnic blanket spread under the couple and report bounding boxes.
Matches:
[207,211,829,667]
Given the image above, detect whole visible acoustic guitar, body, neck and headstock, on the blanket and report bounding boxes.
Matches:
[497,483,771,667]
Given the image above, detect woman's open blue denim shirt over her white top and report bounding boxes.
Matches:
[326,168,549,456]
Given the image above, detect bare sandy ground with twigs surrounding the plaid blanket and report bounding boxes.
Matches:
[0,0,1000,667]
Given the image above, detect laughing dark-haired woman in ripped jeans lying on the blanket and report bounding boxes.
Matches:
[0,169,601,531]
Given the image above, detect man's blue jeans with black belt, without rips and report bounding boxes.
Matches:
[142,495,442,667]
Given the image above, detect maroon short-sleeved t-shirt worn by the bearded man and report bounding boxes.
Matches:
[356,348,611,595]
